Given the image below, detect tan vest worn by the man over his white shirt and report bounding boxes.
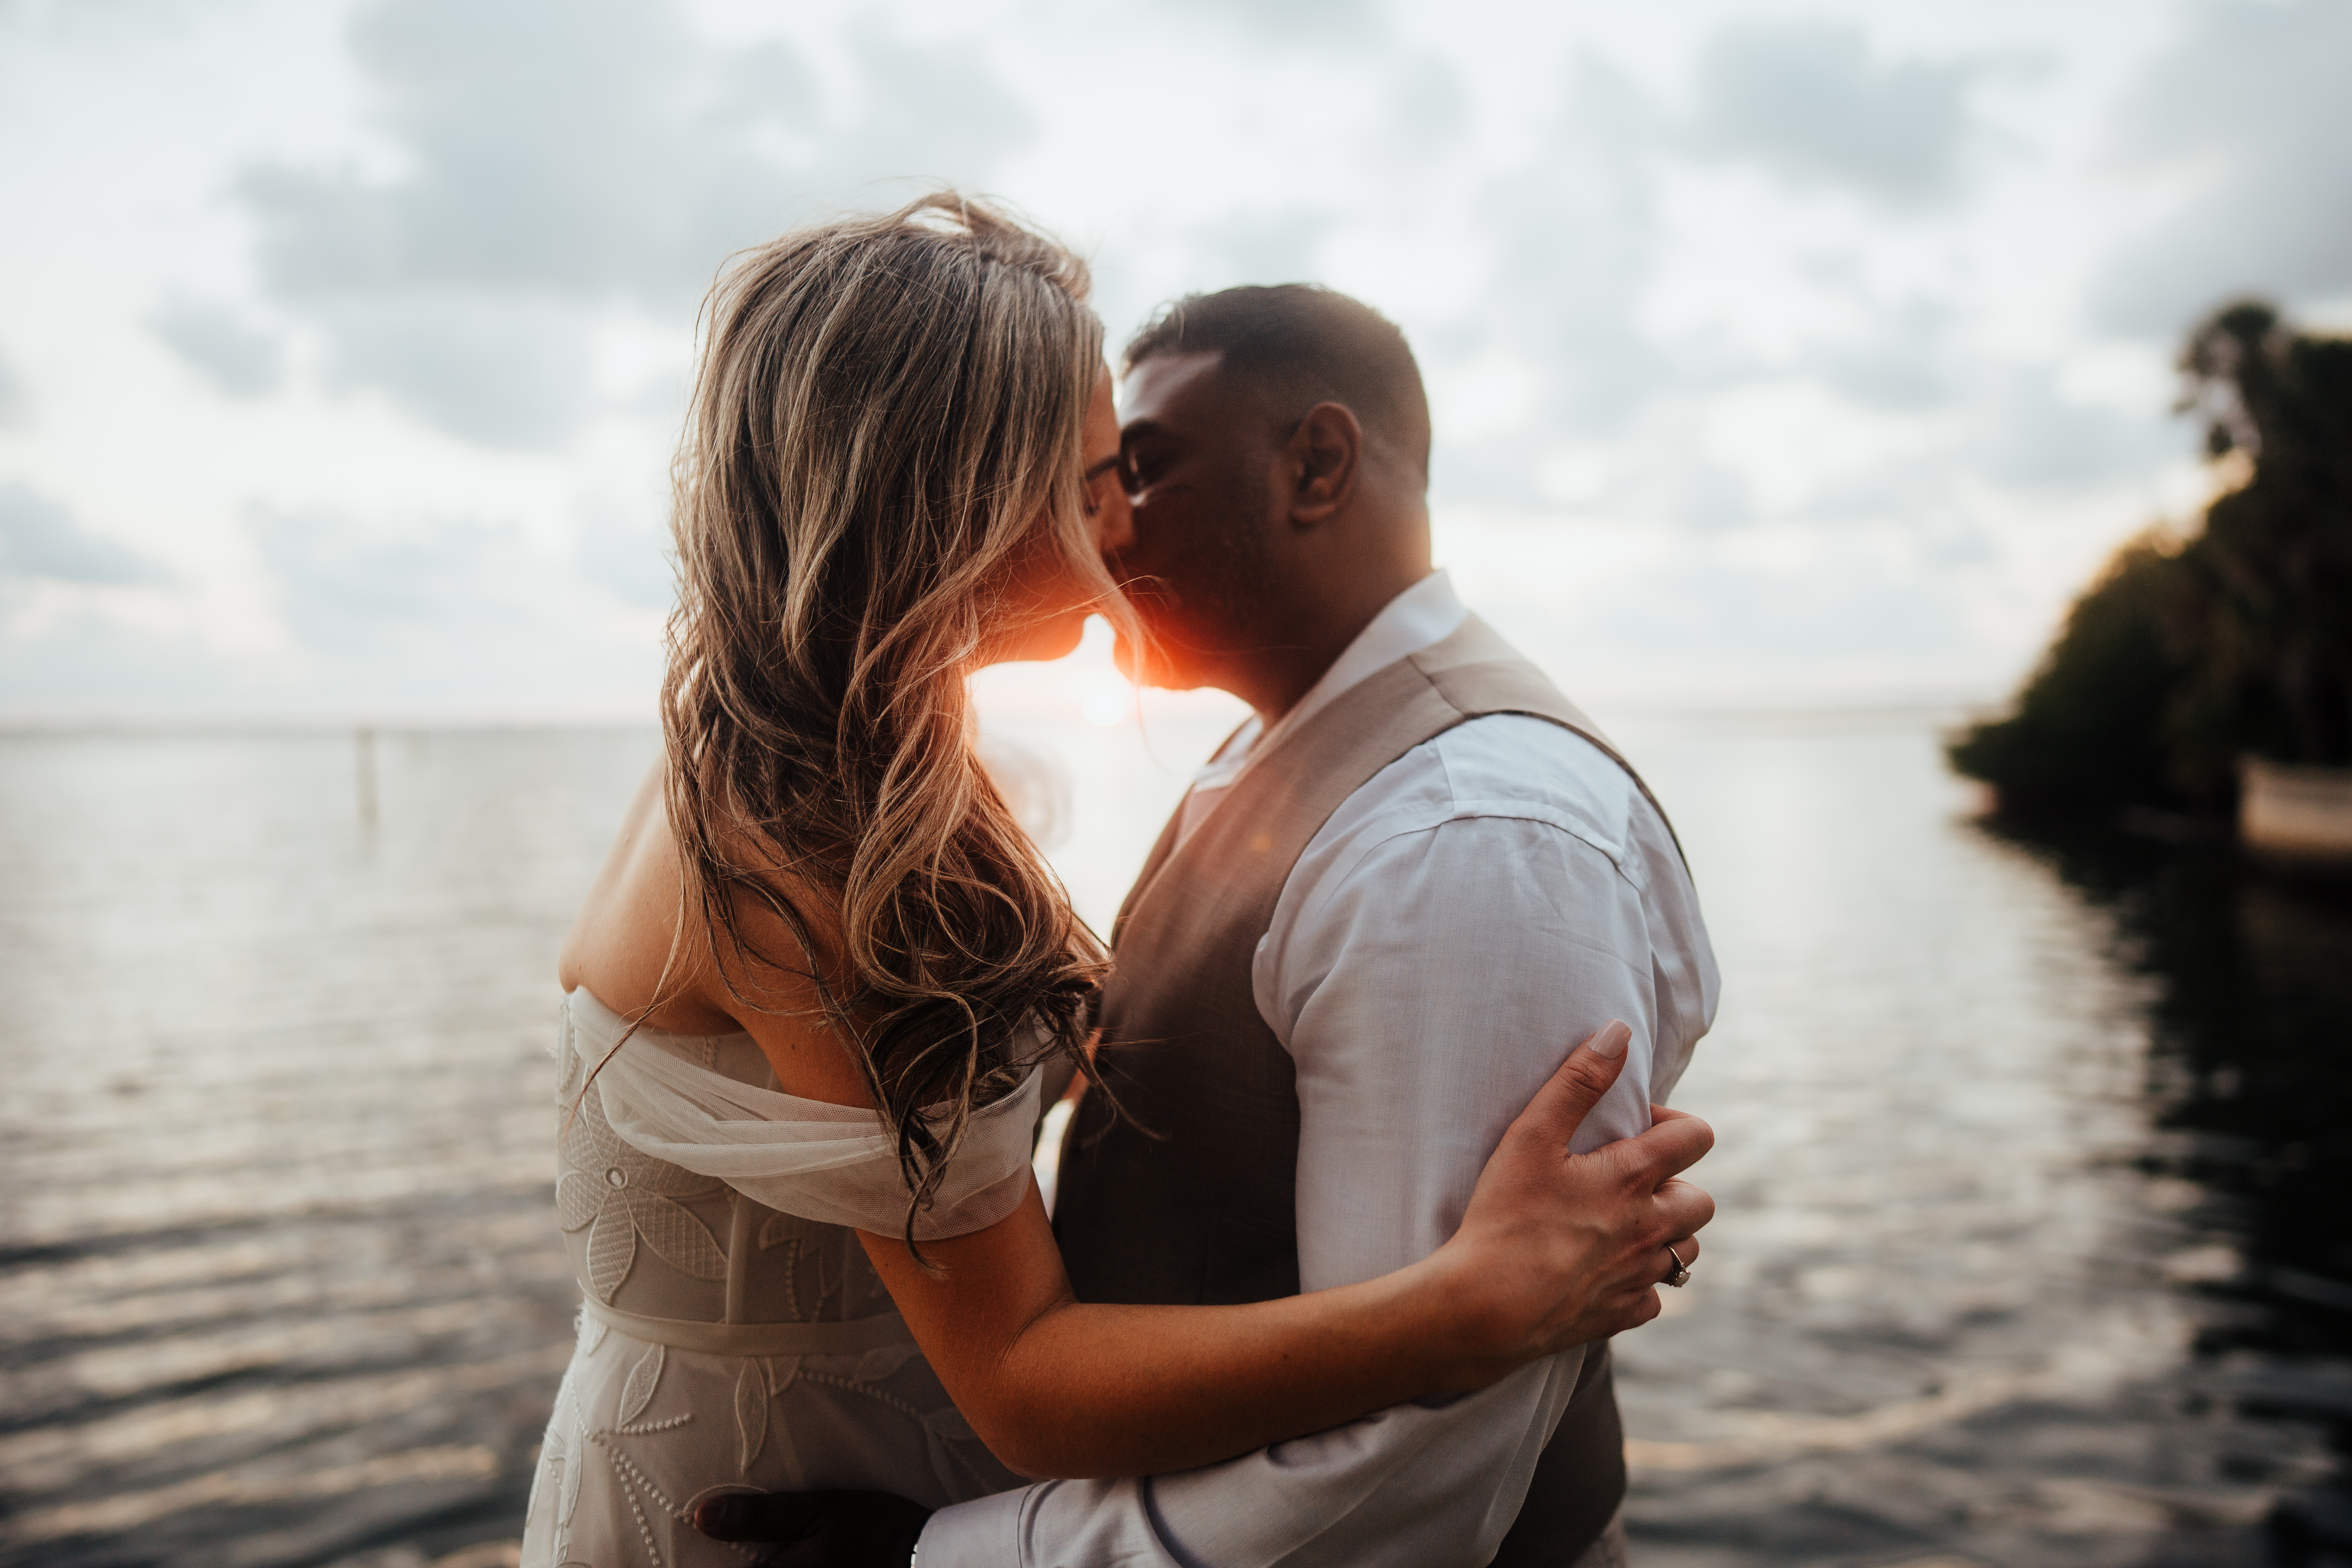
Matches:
[1054,616,1672,1568]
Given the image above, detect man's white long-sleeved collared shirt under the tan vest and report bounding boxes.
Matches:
[920,571,1717,1568]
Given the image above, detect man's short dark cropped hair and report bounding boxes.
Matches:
[1127,282,1430,480]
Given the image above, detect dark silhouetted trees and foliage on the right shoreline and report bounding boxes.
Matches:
[1950,303,2352,809]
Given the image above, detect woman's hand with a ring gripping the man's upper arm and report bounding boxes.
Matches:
[1430,1023,1715,1387]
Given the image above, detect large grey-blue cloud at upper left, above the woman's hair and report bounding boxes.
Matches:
[238,0,1025,447]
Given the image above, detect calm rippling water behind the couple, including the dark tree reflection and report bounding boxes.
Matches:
[0,719,2352,1568]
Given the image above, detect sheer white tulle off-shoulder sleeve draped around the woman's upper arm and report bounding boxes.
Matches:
[595,1034,1040,1241]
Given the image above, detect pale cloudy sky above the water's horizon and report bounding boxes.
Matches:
[0,0,2352,717]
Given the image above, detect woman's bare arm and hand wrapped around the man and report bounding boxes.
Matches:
[861,1025,1712,1479]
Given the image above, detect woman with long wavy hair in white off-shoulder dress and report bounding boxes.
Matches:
[525,195,1710,1566]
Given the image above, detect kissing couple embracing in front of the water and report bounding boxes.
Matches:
[522,193,1717,1568]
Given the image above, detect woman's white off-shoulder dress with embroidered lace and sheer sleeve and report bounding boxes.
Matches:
[522,990,1059,1568]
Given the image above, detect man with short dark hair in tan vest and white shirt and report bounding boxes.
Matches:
[705,285,1717,1568]
